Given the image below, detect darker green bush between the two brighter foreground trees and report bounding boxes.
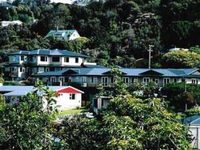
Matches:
[57,116,105,150]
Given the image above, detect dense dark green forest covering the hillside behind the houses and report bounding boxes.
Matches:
[0,0,200,67]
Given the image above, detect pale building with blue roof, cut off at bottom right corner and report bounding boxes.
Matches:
[183,115,200,149]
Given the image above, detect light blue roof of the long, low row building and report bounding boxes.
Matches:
[37,67,198,77]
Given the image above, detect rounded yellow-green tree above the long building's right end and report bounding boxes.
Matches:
[162,50,200,68]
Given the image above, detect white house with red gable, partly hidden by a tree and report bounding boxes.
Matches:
[0,86,84,110]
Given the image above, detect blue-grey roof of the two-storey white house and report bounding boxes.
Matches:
[9,49,88,58]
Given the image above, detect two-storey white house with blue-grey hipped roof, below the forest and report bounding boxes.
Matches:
[4,49,96,80]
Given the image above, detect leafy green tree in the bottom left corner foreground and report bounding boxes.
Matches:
[0,84,55,150]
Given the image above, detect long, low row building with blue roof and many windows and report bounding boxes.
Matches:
[34,67,200,87]
